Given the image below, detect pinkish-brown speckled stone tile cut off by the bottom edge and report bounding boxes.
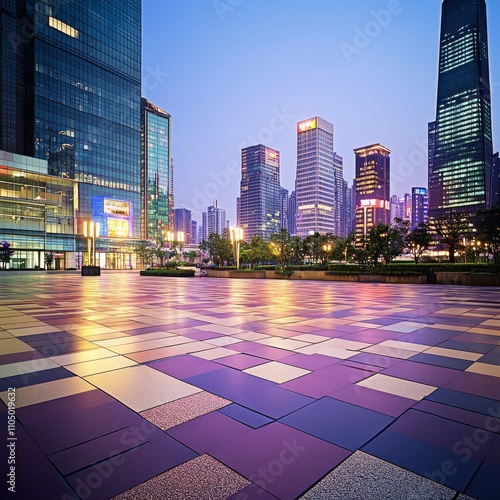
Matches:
[114,455,250,500]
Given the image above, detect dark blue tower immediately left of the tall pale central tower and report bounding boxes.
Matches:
[239,144,281,241]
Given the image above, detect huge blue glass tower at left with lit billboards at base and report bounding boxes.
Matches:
[0,0,142,268]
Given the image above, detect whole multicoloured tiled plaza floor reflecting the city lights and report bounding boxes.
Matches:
[0,272,500,500]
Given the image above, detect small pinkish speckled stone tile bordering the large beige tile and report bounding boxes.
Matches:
[141,391,231,430]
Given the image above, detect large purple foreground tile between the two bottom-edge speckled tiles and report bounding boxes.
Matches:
[214,423,350,499]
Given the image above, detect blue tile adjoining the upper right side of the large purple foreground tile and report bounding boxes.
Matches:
[280,397,394,451]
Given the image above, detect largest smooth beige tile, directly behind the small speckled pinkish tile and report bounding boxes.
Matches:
[85,365,201,412]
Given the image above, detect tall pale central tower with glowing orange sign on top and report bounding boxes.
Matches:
[295,116,335,238]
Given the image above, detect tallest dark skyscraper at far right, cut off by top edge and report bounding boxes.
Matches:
[429,0,493,217]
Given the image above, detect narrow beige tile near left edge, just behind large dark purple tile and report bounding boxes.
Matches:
[0,377,95,408]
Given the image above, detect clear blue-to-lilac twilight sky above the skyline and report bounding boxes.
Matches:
[143,0,500,225]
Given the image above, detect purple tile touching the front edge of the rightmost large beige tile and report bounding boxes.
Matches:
[328,385,415,417]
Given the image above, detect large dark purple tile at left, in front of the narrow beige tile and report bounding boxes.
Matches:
[16,390,142,454]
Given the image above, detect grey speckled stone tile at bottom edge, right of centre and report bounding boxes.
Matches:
[300,451,456,500]
